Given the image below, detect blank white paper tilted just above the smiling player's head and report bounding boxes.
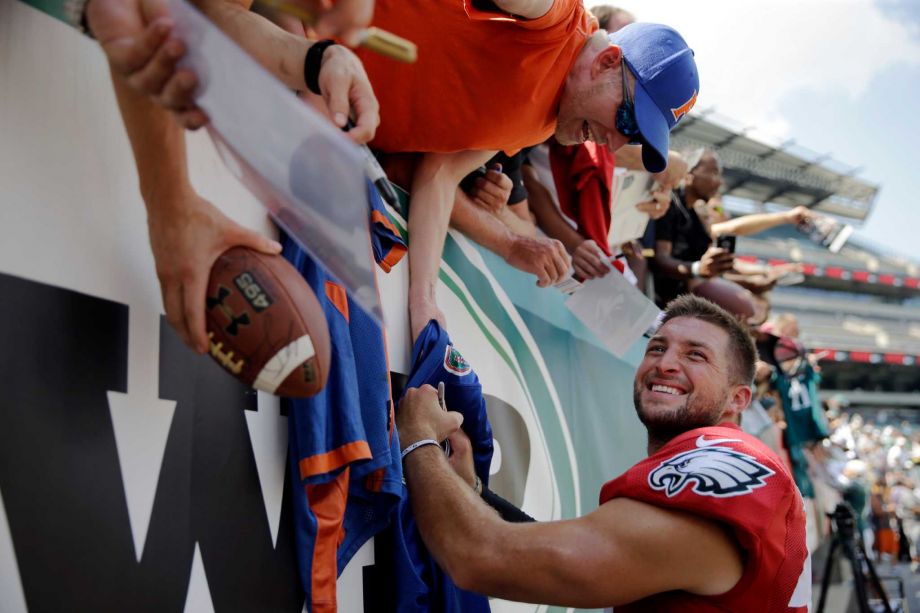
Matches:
[565,270,661,357]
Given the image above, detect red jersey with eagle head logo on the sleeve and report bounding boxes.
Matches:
[600,423,811,613]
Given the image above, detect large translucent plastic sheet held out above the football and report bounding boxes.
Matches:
[170,0,383,324]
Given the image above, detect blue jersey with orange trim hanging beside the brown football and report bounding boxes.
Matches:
[282,179,405,613]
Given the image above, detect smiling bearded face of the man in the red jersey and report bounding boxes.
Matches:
[633,317,737,440]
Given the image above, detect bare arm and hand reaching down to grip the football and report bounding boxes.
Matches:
[112,72,281,353]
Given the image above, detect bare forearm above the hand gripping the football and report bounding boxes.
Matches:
[112,69,191,202]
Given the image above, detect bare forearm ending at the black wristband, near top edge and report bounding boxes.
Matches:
[193,0,313,91]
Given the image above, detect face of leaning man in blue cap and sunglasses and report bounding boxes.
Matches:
[556,45,635,151]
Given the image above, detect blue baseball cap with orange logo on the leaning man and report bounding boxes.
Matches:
[607,23,700,172]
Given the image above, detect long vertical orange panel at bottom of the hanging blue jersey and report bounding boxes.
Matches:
[304,468,350,613]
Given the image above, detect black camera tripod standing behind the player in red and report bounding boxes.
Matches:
[816,502,901,613]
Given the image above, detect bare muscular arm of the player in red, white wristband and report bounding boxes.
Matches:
[397,387,743,608]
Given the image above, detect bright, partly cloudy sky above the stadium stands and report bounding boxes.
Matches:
[585,0,920,262]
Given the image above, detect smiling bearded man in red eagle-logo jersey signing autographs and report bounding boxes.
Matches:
[397,295,811,613]
